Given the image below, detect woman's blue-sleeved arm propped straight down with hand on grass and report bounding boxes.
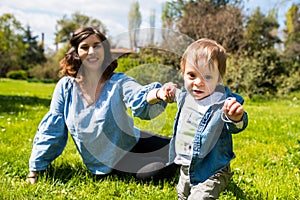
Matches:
[28,77,68,183]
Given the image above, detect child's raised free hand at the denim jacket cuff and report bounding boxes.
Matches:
[223,98,244,122]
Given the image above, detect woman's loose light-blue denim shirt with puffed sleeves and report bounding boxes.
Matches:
[29,73,166,174]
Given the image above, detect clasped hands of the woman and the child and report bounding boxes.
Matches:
[156,82,177,103]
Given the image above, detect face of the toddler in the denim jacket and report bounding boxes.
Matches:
[183,59,219,100]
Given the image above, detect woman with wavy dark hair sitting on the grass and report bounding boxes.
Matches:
[28,27,174,183]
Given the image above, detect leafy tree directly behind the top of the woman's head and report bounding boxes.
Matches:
[55,12,107,50]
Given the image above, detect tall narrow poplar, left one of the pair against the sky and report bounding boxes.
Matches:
[128,1,142,50]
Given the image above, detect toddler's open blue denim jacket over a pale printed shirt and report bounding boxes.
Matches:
[170,86,248,185]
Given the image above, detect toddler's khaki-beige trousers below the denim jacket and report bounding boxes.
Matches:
[177,165,233,200]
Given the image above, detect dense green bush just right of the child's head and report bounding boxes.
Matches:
[225,49,285,98]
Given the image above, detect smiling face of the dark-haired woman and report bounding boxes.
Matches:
[77,35,105,70]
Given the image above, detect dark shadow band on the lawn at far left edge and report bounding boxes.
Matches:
[0,95,51,113]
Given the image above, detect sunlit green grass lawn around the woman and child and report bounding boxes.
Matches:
[0,79,300,199]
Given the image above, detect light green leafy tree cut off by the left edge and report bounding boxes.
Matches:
[0,14,25,77]
